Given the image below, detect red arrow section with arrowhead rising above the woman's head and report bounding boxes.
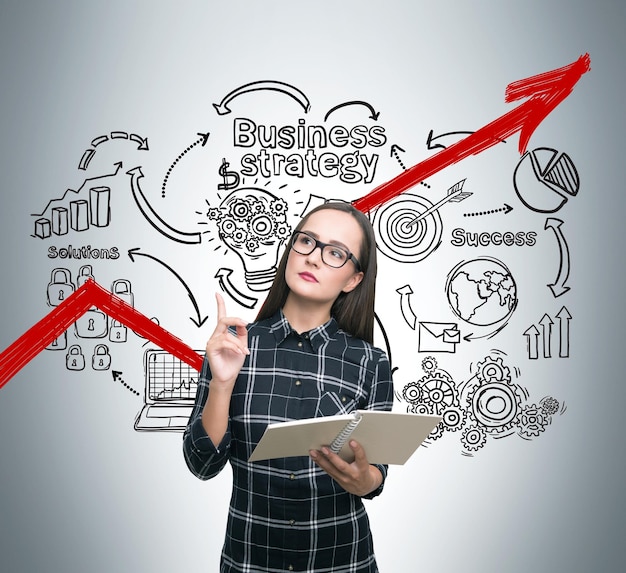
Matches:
[352,54,591,212]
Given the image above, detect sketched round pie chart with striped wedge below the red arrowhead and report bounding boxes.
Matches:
[513,147,580,213]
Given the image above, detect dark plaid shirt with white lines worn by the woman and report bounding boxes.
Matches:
[183,311,393,573]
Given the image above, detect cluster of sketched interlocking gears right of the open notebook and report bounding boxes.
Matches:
[396,350,565,456]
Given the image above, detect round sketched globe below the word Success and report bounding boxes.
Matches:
[446,257,517,326]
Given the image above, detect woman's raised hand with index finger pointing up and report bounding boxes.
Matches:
[206,293,250,390]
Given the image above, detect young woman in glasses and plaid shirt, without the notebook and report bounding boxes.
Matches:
[183,202,393,573]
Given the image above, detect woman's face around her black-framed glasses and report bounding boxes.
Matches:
[285,209,363,306]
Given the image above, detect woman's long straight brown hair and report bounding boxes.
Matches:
[256,201,377,344]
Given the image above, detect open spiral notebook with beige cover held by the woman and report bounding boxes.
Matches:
[248,410,442,465]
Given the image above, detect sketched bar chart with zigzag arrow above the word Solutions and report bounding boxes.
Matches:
[31,163,122,239]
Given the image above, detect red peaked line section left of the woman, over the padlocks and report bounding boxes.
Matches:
[0,279,202,388]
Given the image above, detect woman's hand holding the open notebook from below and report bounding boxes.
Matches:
[309,440,383,496]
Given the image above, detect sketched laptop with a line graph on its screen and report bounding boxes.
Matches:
[135,350,199,432]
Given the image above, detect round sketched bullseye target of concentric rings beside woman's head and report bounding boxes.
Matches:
[372,193,443,263]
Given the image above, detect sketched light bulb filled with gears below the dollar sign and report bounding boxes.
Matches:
[207,187,291,291]
